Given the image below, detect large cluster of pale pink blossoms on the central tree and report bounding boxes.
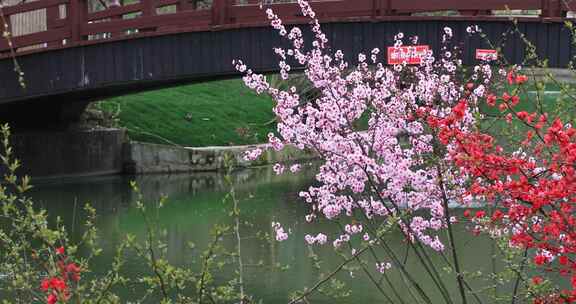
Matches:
[235,0,491,251]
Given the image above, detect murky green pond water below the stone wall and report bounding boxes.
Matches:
[0,168,506,303]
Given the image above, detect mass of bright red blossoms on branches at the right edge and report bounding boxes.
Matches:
[427,71,576,303]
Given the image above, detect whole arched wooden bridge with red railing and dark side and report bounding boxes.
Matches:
[0,0,576,125]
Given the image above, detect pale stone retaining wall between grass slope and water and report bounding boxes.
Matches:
[124,142,314,174]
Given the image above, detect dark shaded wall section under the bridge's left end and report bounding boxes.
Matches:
[11,129,126,178]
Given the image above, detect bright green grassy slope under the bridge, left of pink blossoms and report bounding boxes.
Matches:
[98,79,275,146]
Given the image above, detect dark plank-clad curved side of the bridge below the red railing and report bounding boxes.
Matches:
[0,20,575,111]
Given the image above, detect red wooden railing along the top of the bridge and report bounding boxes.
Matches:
[0,0,576,57]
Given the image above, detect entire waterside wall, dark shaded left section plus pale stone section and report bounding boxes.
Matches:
[0,129,315,179]
